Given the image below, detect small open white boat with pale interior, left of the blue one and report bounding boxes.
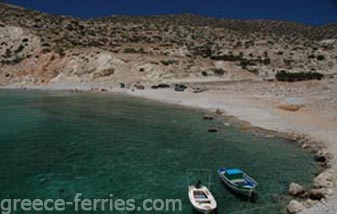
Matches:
[188,184,217,213]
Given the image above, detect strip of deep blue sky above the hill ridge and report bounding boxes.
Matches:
[4,0,337,25]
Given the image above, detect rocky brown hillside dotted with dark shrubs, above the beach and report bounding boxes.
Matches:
[0,3,337,87]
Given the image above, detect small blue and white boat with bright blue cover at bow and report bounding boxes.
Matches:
[218,168,257,198]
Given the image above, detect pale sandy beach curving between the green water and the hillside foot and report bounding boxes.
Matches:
[0,79,337,214]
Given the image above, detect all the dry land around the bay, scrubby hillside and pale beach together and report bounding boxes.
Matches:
[0,3,337,214]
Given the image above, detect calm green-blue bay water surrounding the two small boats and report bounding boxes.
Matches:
[0,90,317,213]
